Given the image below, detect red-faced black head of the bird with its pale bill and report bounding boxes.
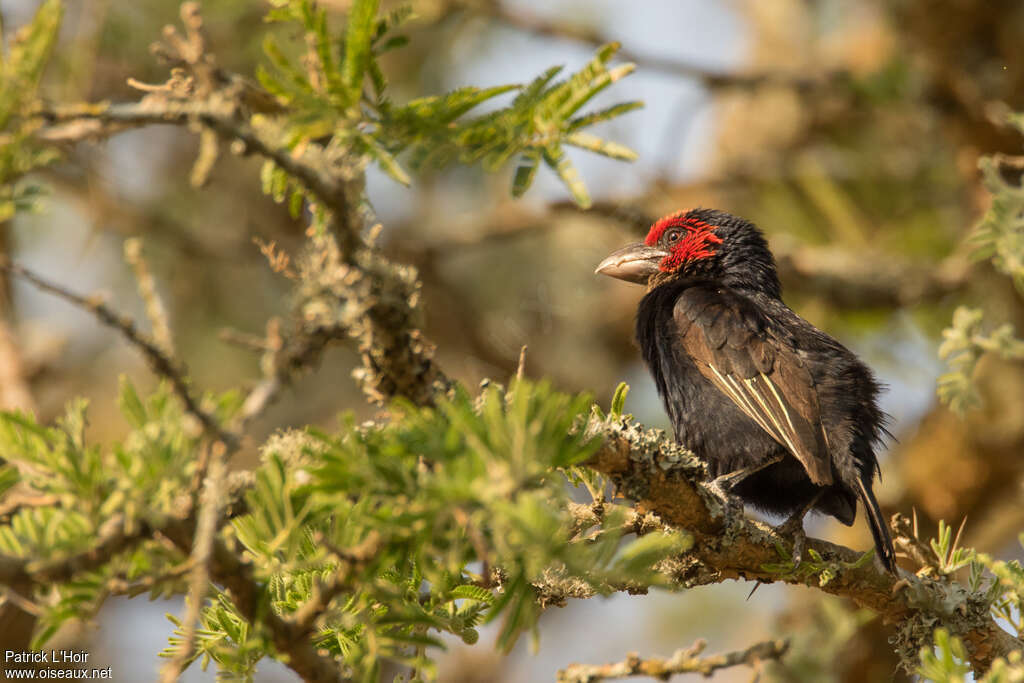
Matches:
[595,209,780,297]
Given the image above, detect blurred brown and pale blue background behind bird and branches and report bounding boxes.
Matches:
[0,0,1024,683]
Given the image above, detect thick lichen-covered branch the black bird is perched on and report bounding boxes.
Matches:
[589,419,1024,674]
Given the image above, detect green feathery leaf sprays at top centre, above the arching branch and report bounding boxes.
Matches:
[258,0,641,206]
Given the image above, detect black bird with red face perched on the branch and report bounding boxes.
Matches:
[596,208,896,573]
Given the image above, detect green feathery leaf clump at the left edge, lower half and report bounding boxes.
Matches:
[0,381,205,646]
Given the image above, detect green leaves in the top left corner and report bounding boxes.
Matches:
[0,0,63,222]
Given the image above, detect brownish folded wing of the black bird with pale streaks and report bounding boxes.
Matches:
[673,287,833,485]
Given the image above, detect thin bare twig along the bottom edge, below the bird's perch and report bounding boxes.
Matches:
[558,640,790,683]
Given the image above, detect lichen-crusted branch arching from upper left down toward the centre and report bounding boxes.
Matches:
[37,91,450,411]
